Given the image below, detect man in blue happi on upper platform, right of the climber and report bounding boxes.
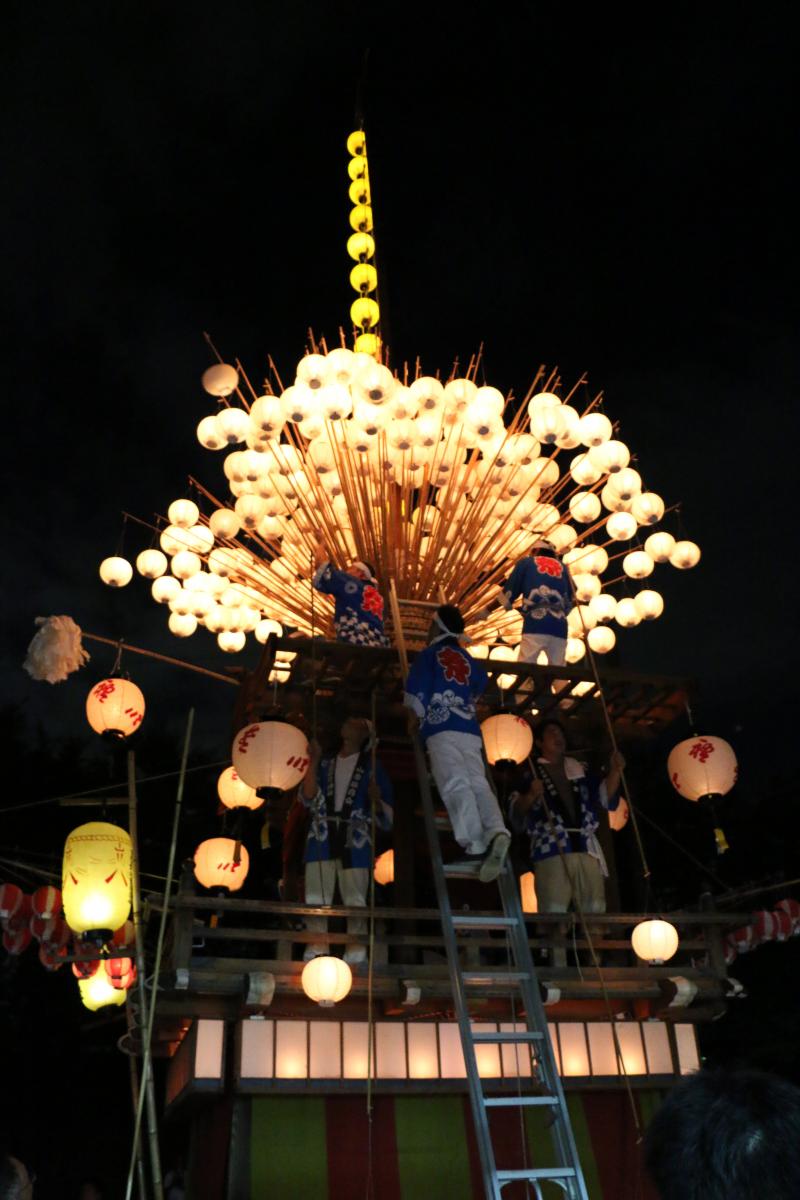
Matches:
[499,538,575,666]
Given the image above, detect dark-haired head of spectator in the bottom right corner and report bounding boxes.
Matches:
[644,1070,800,1200]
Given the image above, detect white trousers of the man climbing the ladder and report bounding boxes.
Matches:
[428,731,507,854]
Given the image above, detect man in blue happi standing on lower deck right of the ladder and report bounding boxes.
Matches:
[510,718,625,966]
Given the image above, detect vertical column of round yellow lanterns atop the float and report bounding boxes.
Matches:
[347,130,380,360]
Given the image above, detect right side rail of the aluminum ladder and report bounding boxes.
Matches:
[498,863,589,1200]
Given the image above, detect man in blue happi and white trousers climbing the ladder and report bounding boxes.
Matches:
[404,605,511,882]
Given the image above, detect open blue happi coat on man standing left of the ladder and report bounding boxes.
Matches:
[299,751,395,868]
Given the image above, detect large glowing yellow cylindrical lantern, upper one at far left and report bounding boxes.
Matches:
[61,821,133,941]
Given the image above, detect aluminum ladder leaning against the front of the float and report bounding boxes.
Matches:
[413,734,589,1200]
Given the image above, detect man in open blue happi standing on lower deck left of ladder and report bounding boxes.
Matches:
[299,716,393,962]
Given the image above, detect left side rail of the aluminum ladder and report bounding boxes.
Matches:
[411,733,501,1200]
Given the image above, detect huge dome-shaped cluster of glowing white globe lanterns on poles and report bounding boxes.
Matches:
[100,348,700,680]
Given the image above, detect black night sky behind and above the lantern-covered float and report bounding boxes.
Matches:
[0,2,800,1190]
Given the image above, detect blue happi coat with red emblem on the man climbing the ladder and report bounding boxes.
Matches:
[403,636,488,742]
